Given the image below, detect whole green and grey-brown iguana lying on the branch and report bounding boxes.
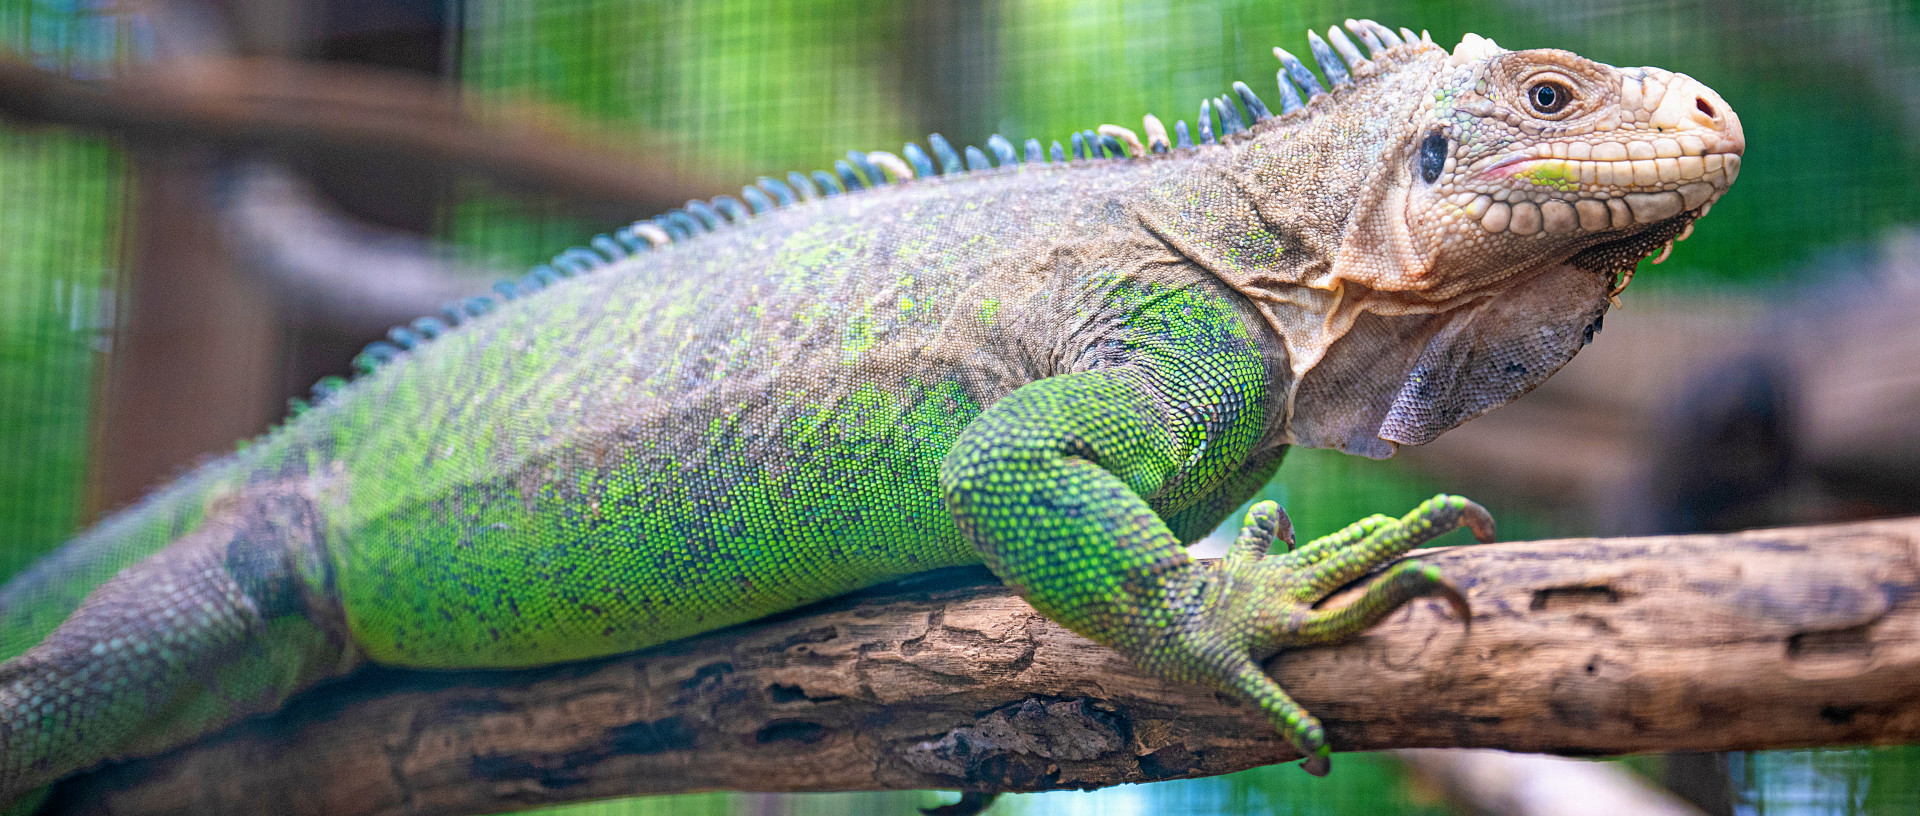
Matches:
[0,21,1745,801]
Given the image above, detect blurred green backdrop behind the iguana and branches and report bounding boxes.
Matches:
[0,0,1920,814]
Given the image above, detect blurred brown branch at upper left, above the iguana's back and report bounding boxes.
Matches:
[0,58,718,211]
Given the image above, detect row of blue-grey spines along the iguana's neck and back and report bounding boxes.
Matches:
[294,19,1432,415]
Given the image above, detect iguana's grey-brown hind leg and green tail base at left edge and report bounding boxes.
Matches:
[0,470,353,804]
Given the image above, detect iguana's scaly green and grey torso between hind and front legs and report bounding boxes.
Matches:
[316,159,1251,666]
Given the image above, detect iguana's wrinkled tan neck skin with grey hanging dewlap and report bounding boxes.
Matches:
[1140,46,1628,459]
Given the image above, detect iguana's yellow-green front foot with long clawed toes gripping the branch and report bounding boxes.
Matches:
[1164,495,1494,776]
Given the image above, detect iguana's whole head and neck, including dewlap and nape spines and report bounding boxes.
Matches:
[1142,19,1745,457]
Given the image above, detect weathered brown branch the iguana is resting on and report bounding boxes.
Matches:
[41,518,1920,816]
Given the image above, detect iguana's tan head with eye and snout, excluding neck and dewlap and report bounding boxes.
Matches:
[1332,35,1747,300]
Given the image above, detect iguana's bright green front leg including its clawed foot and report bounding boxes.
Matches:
[941,365,1492,774]
